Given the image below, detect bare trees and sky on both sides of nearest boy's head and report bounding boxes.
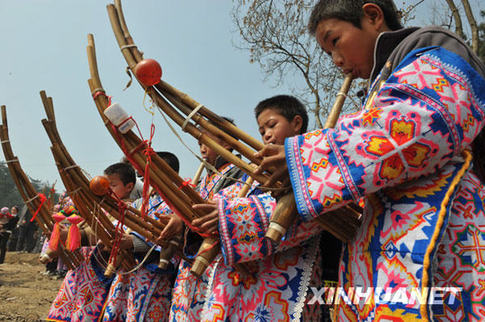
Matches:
[233,0,485,128]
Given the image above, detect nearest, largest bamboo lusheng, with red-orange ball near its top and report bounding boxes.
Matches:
[107,0,360,247]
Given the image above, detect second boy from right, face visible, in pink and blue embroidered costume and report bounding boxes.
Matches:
[187,95,328,321]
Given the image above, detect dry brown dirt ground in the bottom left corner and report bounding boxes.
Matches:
[0,252,62,321]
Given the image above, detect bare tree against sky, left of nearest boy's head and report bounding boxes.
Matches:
[233,0,360,128]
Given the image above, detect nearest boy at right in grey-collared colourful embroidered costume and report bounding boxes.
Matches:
[255,0,485,321]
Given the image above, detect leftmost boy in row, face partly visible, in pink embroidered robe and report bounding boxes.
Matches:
[47,163,135,321]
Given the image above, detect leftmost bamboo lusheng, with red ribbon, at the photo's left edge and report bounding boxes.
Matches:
[0,105,83,269]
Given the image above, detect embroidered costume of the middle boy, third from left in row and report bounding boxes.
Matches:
[170,163,241,321]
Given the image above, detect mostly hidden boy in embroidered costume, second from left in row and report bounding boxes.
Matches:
[102,152,182,321]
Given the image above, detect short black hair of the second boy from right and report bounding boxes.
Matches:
[254,95,308,134]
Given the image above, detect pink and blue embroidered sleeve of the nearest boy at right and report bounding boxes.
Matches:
[285,48,485,221]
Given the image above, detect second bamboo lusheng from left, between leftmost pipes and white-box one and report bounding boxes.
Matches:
[40,91,137,276]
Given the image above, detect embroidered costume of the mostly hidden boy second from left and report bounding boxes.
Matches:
[103,195,174,321]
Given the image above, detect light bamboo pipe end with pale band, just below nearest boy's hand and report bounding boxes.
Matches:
[265,193,297,243]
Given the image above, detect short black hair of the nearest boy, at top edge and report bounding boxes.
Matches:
[308,0,403,35]
